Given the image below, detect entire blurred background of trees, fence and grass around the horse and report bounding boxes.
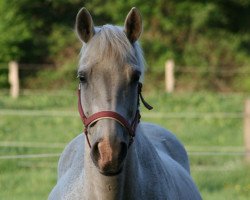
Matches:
[0,0,250,200]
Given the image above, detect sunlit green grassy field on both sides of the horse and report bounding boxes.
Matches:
[0,91,250,200]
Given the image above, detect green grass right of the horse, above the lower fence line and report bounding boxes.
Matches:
[145,93,247,146]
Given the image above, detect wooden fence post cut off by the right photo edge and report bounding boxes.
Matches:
[244,99,250,161]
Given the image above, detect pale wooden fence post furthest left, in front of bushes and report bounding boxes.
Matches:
[9,61,19,98]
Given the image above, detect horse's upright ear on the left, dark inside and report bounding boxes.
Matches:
[76,7,95,43]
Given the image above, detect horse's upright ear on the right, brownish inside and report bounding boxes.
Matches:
[124,7,142,43]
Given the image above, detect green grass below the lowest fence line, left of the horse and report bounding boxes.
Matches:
[0,159,57,200]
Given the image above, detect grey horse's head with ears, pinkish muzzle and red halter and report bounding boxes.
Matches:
[76,8,144,175]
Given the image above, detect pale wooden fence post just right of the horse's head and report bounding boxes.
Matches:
[165,59,175,93]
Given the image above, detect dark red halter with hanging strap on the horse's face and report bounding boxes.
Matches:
[78,83,153,148]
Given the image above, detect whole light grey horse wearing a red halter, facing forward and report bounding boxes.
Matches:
[49,7,201,200]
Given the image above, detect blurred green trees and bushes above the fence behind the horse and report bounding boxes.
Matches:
[0,0,250,90]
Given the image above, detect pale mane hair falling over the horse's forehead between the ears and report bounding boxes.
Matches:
[79,24,145,74]
